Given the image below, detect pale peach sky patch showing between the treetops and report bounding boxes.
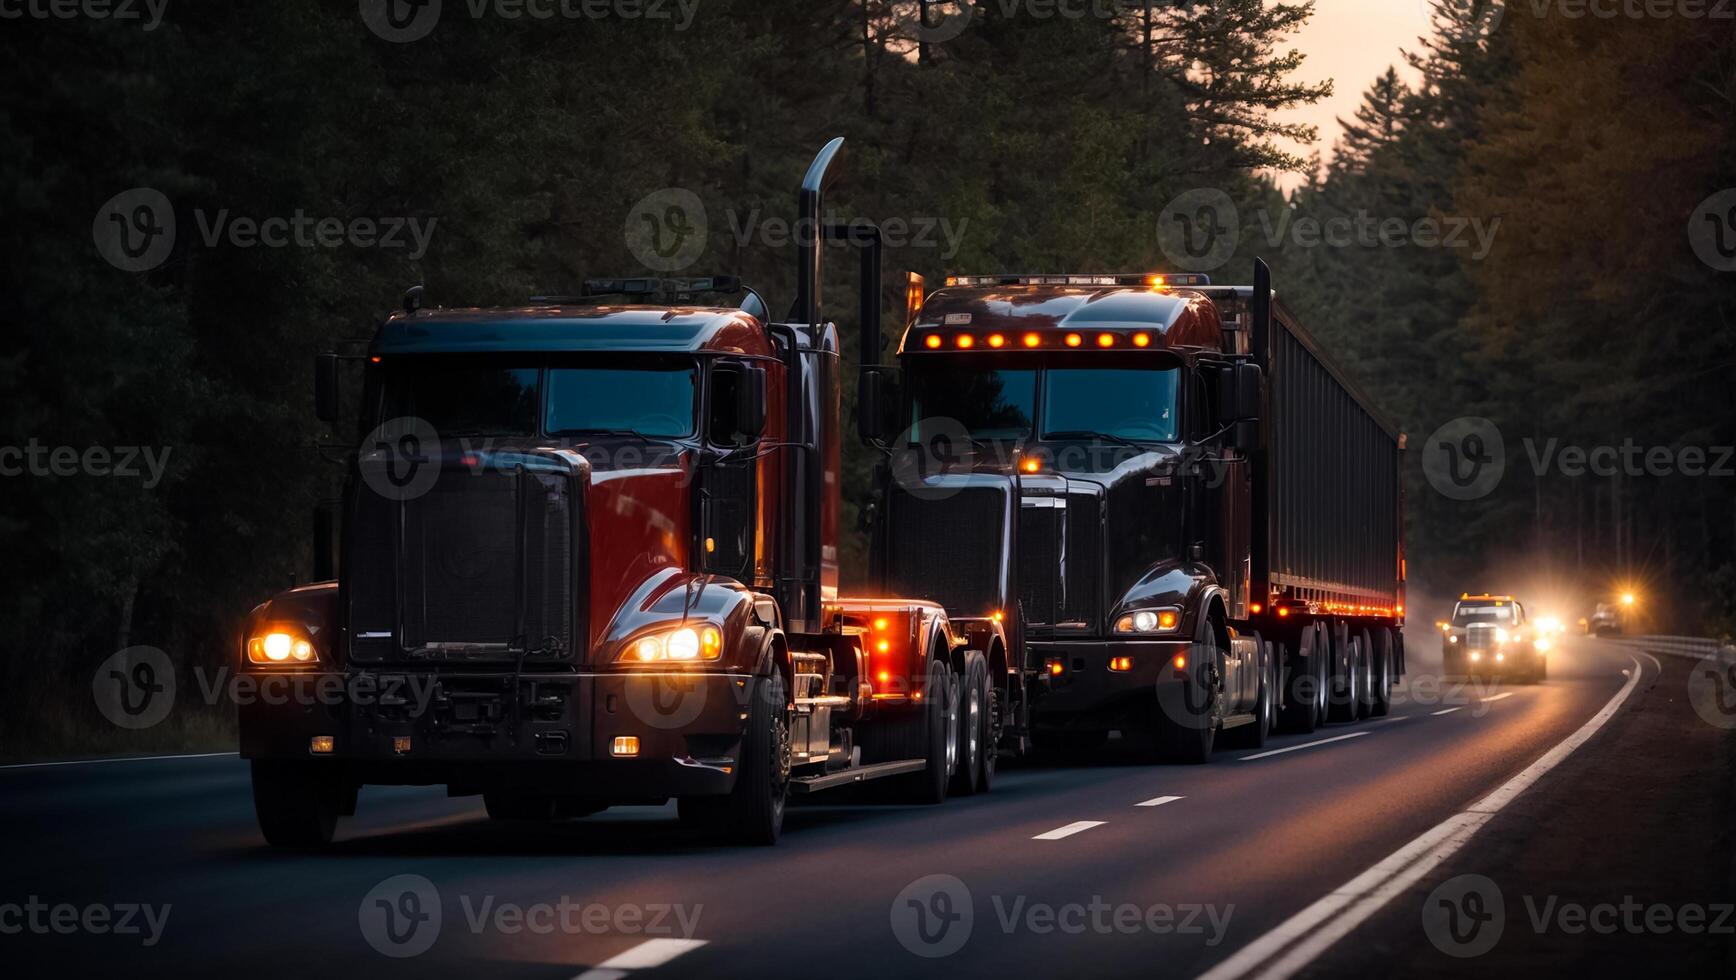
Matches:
[1279,0,1429,187]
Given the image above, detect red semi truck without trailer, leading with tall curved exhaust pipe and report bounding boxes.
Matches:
[240,139,1021,846]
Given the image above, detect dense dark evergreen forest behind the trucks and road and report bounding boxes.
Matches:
[0,0,1736,751]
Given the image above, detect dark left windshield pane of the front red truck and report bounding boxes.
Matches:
[384,356,538,437]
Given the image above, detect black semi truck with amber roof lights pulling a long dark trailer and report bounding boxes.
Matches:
[863,262,1404,763]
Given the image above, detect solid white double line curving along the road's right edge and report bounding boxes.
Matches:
[1200,659,1641,980]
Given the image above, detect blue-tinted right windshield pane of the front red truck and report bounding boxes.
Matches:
[545,368,696,439]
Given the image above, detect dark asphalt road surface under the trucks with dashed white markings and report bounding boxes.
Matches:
[0,631,1680,980]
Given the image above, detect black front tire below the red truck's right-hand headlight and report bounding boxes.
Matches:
[675,670,790,846]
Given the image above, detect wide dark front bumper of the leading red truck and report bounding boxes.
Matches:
[236,670,760,805]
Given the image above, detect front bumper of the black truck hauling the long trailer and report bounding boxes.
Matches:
[1029,640,1191,725]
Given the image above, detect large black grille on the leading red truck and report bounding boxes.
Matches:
[345,470,576,661]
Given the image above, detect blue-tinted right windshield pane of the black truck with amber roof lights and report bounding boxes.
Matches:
[1043,368,1180,442]
